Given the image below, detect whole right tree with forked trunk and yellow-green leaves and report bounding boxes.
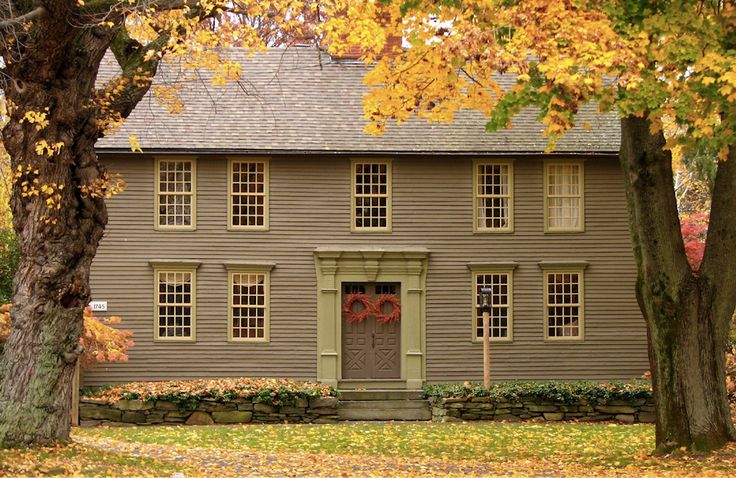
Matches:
[328,0,736,452]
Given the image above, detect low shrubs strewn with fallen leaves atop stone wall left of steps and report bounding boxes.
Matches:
[84,378,337,409]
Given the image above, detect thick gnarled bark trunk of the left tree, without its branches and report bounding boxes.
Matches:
[0,12,112,447]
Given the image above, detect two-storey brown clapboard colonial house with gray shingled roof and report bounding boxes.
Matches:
[85,48,648,389]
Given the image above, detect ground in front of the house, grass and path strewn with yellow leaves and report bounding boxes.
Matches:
[0,423,736,477]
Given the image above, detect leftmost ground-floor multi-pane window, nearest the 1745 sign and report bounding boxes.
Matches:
[155,270,195,340]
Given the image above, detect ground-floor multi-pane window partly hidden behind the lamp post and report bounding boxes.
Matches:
[473,272,512,340]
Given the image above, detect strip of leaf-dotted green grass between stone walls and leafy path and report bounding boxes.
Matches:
[83,423,654,466]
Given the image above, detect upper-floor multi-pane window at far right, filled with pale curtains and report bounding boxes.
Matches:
[545,162,584,232]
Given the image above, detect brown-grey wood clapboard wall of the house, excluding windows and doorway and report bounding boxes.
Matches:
[85,155,648,385]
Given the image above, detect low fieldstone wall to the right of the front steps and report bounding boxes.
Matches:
[430,397,656,423]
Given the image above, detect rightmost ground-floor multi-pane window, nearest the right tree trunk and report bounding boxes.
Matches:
[545,271,583,339]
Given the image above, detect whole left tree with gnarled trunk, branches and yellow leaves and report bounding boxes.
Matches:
[0,0,330,447]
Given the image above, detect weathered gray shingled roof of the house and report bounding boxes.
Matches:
[98,48,620,154]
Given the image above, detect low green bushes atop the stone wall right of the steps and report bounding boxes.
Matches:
[424,380,653,404]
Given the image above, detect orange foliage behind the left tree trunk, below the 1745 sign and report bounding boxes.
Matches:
[0,304,134,368]
